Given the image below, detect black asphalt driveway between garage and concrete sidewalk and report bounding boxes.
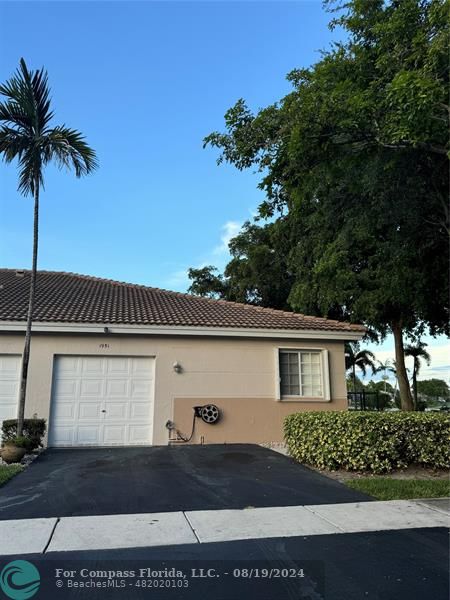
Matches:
[0,444,371,519]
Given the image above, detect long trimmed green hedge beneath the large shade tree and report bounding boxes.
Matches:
[284,411,450,473]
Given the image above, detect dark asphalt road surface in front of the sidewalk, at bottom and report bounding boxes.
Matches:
[0,528,449,600]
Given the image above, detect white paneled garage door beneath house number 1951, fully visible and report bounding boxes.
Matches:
[49,356,154,446]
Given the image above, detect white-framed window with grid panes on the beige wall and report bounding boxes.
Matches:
[279,350,325,398]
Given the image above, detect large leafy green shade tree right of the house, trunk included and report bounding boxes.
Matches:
[192,0,449,410]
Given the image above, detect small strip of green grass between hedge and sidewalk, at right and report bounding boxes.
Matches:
[345,477,450,500]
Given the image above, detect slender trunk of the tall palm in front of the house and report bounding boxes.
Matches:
[17,181,39,435]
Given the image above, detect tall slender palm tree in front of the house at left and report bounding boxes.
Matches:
[0,58,97,435]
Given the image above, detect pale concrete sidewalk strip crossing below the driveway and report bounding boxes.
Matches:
[0,498,450,555]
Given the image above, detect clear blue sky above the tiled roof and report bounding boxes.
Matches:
[0,0,450,378]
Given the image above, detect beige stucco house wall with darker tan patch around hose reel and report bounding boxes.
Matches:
[0,333,346,444]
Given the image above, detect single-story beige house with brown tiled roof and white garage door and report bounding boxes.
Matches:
[0,269,364,447]
